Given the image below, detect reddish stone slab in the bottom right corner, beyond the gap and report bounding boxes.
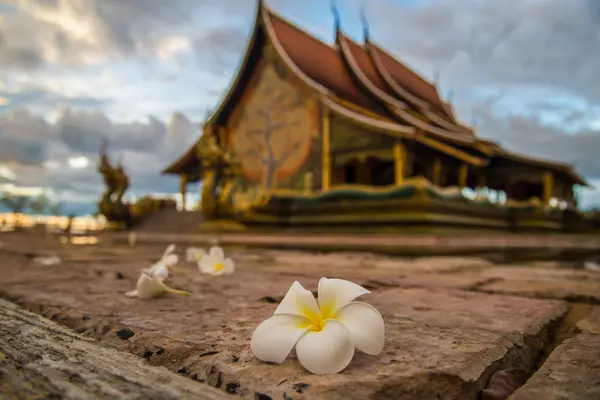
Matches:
[510,333,600,400]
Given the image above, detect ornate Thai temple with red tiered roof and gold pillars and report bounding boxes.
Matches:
[163,0,587,231]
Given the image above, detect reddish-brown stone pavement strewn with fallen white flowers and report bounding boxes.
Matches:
[0,235,600,400]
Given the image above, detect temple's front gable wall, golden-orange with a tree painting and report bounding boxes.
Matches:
[226,45,321,191]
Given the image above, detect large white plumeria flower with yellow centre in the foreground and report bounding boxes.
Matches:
[250,278,385,374]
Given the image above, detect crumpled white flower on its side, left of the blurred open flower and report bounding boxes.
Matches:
[125,245,190,299]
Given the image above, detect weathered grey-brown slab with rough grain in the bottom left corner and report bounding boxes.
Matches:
[0,299,228,400]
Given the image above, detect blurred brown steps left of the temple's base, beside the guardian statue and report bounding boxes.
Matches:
[134,210,202,233]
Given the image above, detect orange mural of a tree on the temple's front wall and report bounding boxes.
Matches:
[232,64,316,188]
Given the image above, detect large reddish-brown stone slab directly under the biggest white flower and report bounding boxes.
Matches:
[0,239,568,399]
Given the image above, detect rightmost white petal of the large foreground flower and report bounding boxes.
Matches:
[336,301,385,355]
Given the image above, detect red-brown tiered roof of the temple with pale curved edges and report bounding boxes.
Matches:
[163,0,586,185]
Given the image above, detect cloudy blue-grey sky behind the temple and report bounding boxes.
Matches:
[0,0,600,212]
